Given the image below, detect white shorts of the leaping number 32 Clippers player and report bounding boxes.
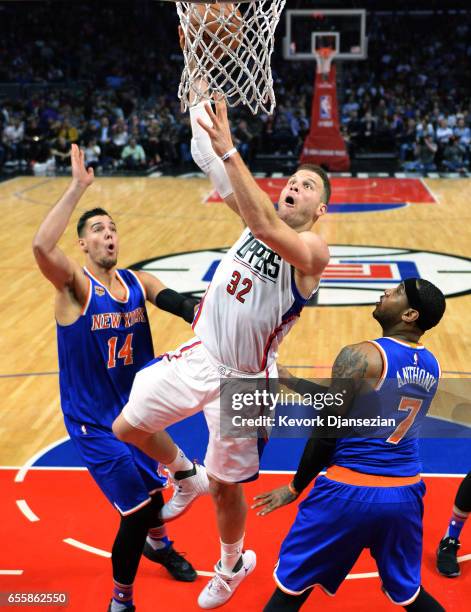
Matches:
[122,338,277,483]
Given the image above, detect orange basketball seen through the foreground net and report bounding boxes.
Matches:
[189,3,243,59]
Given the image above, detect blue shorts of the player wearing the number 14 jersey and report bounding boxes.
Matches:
[64,417,166,516]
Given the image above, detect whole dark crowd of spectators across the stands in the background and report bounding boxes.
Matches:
[0,0,471,172]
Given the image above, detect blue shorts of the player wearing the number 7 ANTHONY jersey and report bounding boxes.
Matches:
[274,476,425,605]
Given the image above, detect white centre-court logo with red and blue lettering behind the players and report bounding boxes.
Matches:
[132,245,471,306]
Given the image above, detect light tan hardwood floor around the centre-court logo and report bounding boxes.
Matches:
[0,177,471,466]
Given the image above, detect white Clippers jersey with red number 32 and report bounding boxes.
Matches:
[193,228,316,373]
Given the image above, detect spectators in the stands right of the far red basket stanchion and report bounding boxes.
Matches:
[341,12,471,171]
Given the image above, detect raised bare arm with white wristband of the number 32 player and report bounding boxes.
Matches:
[198,98,329,276]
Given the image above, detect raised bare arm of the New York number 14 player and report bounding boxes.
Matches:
[33,144,93,291]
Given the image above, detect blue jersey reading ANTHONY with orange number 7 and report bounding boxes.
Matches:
[332,338,440,476]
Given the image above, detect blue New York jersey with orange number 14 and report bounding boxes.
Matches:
[57,268,154,428]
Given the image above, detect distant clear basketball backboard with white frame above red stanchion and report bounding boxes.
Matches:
[283,9,368,60]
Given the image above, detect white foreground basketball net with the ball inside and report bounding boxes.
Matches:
[163,0,286,115]
